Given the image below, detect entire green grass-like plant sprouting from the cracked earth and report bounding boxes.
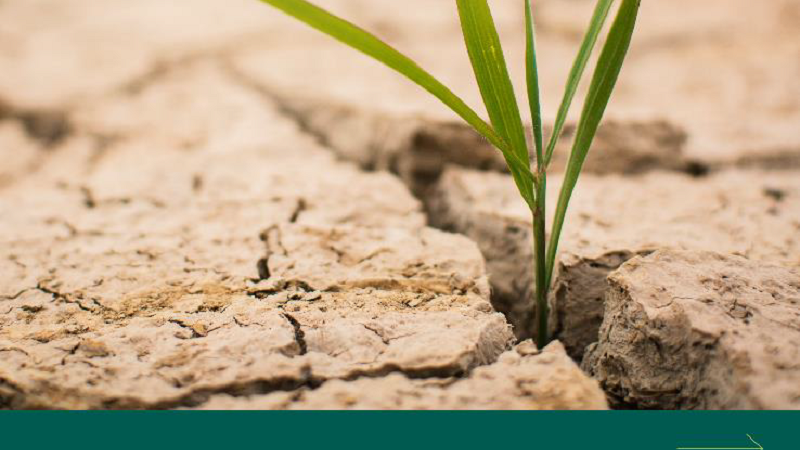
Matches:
[261,0,641,346]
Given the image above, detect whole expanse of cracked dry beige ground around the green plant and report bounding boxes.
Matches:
[0,0,800,409]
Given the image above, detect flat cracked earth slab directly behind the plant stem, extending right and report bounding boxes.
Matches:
[428,168,800,360]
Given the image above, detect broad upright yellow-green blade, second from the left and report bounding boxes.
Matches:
[456,0,535,208]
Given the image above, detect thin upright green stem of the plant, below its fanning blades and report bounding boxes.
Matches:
[533,171,550,348]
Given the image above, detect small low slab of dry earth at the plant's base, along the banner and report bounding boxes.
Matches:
[194,341,607,410]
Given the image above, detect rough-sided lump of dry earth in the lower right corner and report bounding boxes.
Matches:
[584,251,800,409]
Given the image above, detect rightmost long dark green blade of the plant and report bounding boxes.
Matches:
[547,0,641,285]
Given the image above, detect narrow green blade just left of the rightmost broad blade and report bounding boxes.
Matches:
[544,0,614,166]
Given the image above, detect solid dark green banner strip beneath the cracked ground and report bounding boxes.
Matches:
[0,411,800,450]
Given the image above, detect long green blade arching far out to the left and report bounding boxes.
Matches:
[261,0,533,204]
